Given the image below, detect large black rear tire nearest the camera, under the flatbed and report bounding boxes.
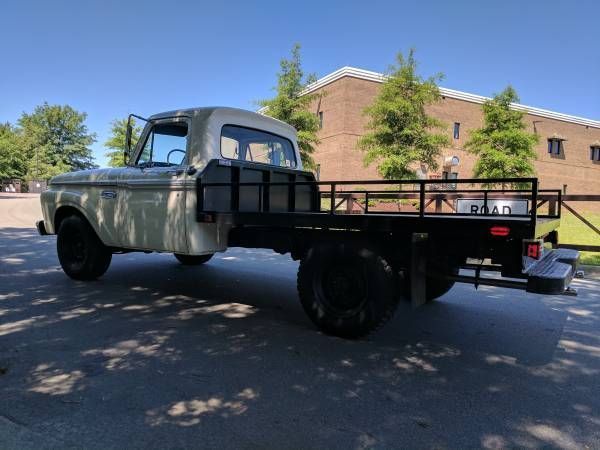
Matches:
[298,244,398,339]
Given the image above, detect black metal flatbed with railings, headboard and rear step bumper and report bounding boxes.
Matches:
[197,161,579,328]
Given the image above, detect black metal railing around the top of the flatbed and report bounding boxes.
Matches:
[197,177,562,223]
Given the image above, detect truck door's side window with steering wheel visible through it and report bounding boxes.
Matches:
[136,122,188,167]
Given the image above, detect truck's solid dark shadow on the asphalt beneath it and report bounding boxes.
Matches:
[103,249,567,365]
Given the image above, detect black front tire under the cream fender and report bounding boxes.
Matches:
[56,216,112,281]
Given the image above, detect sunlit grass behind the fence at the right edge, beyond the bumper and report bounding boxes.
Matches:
[558,208,600,266]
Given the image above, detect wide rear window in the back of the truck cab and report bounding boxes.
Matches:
[221,125,296,168]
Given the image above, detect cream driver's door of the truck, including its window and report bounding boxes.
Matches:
[119,118,189,253]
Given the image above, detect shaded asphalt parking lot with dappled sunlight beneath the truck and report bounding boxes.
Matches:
[0,194,600,449]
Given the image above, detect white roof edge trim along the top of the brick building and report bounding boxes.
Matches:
[303,66,600,128]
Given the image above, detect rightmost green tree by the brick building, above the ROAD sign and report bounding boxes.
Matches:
[465,86,539,186]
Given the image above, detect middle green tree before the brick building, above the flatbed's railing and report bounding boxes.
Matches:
[358,49,450,179]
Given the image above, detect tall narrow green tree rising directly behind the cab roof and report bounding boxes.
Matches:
[258,44,322,170]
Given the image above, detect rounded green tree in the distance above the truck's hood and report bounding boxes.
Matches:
[19,103,97,179]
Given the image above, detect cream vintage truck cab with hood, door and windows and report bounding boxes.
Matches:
[41,107,302,261]
